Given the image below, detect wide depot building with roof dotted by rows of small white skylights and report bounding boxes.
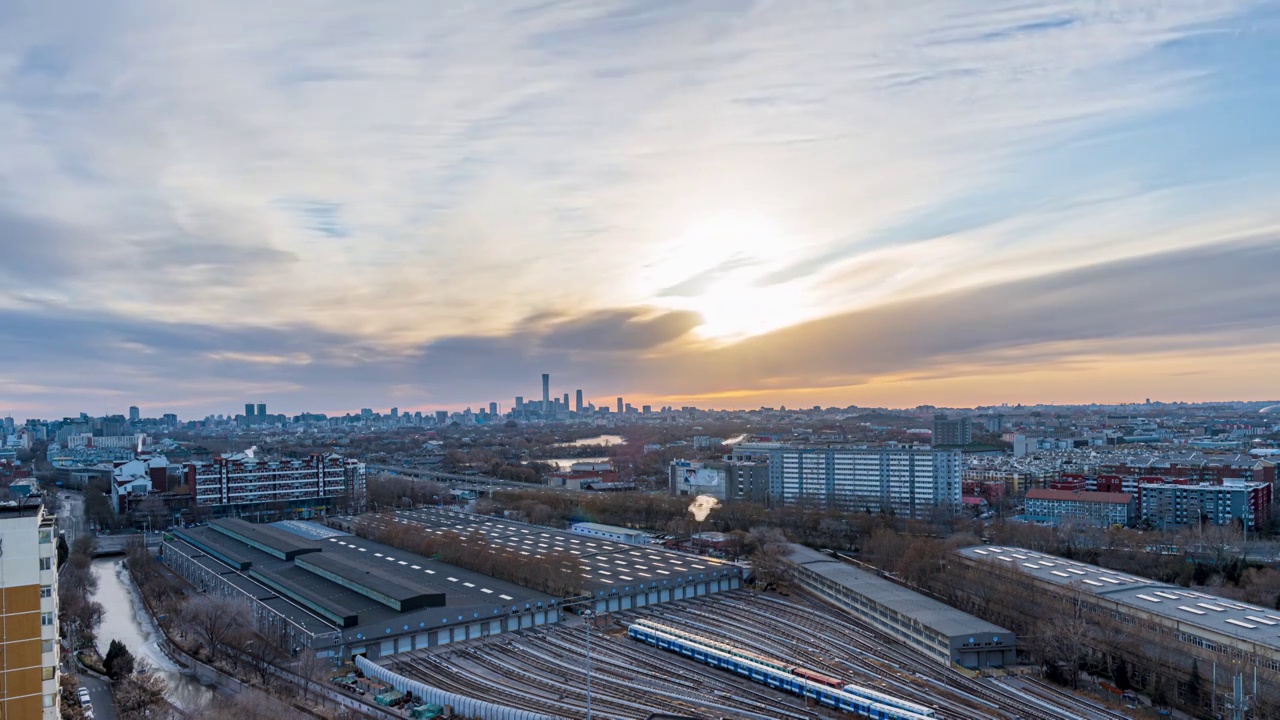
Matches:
[378,507,742,612]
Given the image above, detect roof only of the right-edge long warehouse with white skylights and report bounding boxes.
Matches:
[957,544,1280,648]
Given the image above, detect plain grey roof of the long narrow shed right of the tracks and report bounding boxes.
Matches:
[787,544,1014,637]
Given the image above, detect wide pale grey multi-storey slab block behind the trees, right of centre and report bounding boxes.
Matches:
[735,443,963,518]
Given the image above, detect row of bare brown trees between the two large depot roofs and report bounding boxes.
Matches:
[352,515,584,597]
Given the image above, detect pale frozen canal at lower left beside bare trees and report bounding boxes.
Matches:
[92,557,214,711]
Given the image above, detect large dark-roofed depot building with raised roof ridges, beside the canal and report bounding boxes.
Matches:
[163,519,561,659]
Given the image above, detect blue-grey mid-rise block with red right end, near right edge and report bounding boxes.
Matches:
[1139,478,1271,528]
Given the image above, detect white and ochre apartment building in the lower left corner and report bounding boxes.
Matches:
[0,496,60,720]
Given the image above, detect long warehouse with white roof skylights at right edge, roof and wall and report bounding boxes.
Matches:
[957,546,1280,687]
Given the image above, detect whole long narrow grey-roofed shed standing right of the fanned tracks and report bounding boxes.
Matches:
[786,544,1016,669]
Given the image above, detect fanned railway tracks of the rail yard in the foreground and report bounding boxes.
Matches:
[379,591,1126,720]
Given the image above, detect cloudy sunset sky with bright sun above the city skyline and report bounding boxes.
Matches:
[0,0,1280,418]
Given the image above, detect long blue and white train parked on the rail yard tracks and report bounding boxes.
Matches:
[627,623,934,720]
